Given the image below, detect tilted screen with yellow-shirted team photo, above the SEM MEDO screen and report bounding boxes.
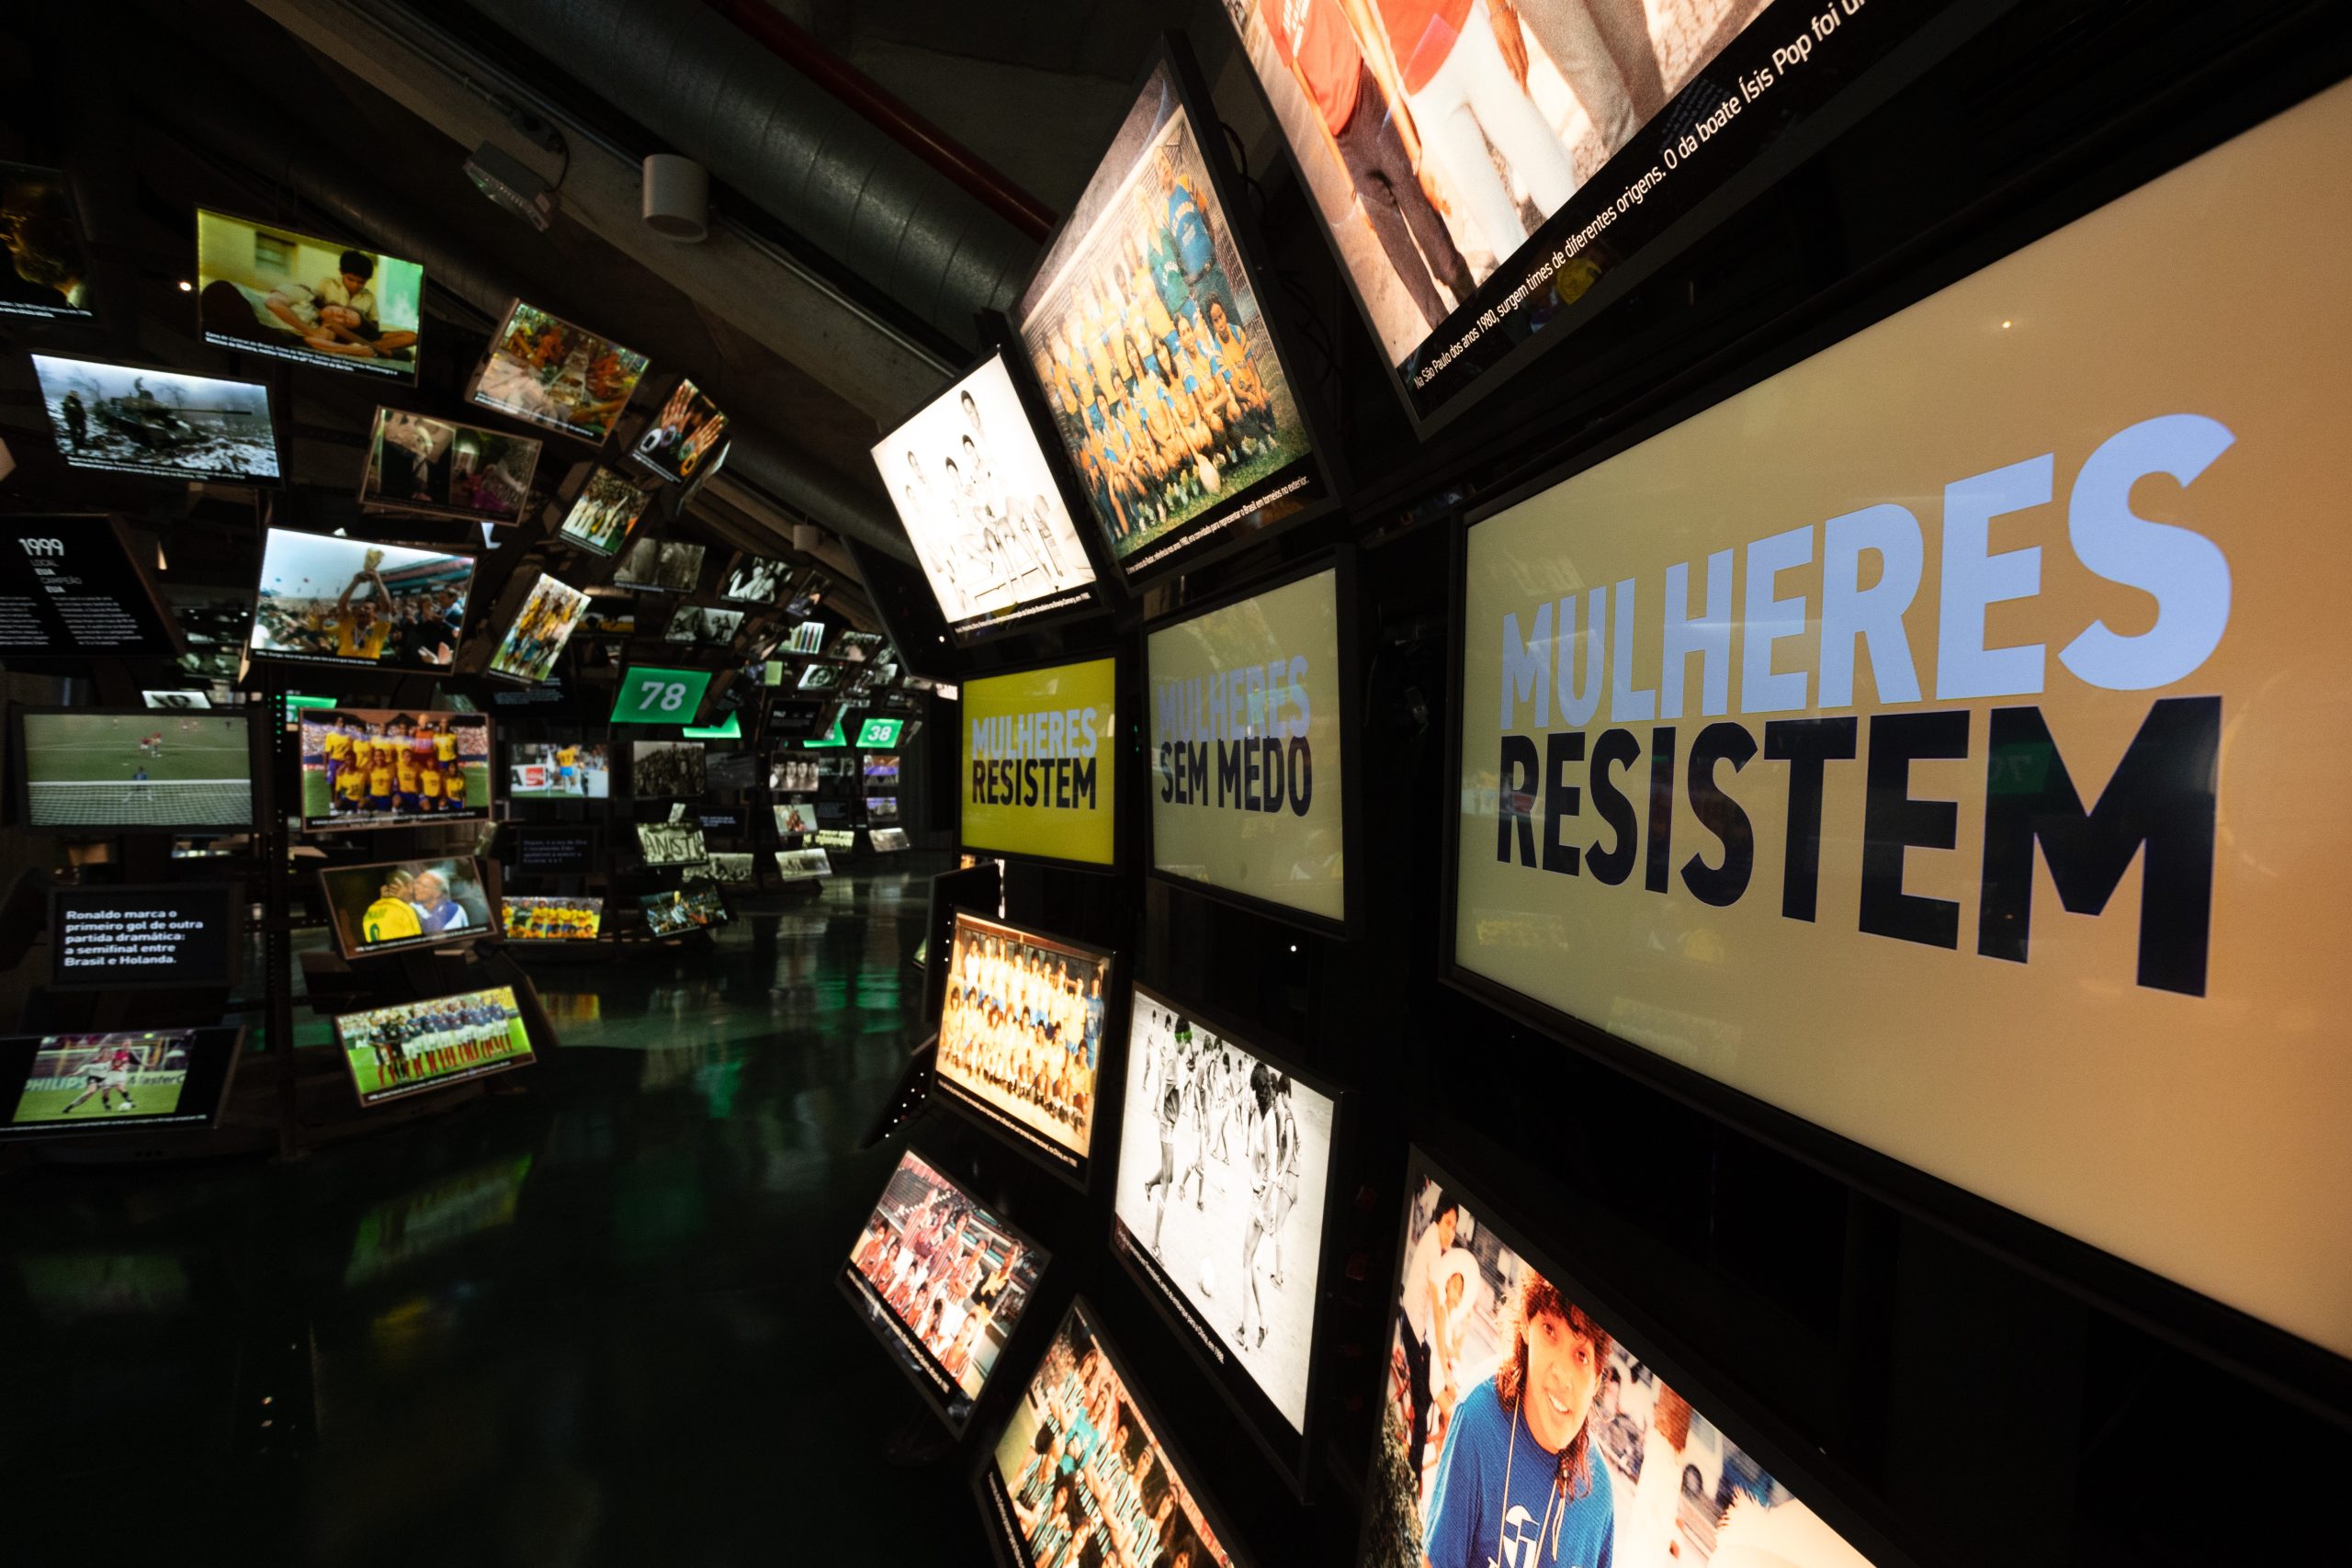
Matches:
[1015,55,1327,579]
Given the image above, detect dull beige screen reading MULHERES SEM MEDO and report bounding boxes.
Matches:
[1143,569,1348,921]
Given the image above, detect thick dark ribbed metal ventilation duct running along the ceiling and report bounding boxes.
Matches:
[473,0,1037,345]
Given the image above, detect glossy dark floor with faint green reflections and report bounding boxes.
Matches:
[0,858,986,1568]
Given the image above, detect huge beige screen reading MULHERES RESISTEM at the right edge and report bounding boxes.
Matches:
[1452,87,2352,1354]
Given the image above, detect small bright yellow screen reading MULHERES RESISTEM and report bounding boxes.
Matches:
[962,659,1120,865]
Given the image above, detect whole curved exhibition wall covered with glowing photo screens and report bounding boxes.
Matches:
[0,0,2352,1568]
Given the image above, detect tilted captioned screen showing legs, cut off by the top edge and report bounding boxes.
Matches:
[1226,0,1984,421]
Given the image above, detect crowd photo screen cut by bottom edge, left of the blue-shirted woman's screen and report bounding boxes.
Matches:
[981,1300,1238,1568]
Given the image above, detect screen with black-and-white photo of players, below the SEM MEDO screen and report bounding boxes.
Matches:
[1113,985,1334,1434]
